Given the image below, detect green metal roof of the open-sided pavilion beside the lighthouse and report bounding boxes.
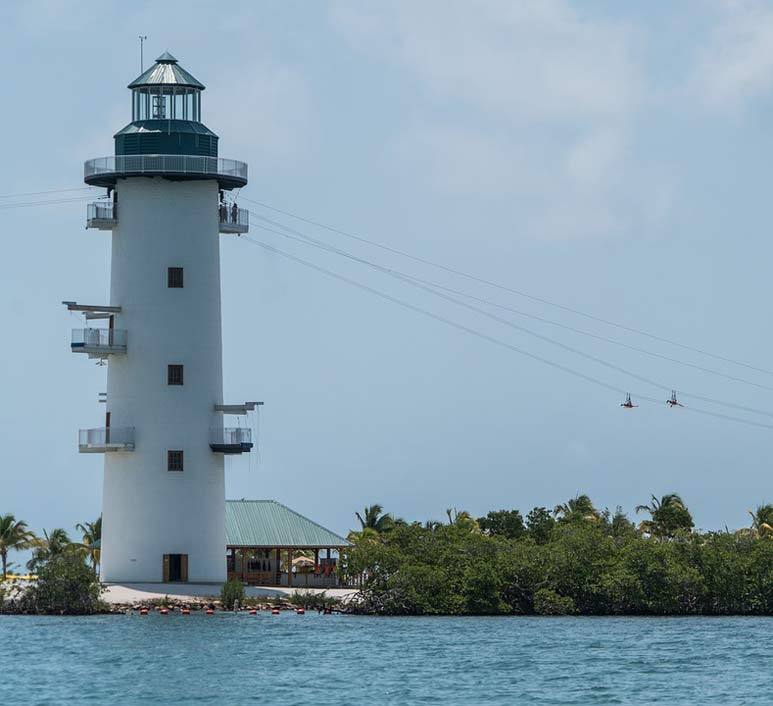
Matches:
[225,500,349,549]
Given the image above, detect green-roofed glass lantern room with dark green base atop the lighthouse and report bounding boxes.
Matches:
[115,52,218,157]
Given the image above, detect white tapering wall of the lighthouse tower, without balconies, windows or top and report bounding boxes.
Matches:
[101,177,226,582]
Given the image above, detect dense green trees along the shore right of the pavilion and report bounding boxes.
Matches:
[340,493,773,615]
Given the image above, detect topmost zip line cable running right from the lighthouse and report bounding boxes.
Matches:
[240,196,773,375]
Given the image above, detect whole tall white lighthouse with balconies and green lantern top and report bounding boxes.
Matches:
[65,53,256,582]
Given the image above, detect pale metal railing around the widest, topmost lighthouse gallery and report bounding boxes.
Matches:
[83,154,247,179]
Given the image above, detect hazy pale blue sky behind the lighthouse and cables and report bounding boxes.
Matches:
[0,0,773,556]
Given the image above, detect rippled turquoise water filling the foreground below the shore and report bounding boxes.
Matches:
[0,612,773,706]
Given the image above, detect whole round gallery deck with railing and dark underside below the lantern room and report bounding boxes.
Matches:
[83,154,247,189]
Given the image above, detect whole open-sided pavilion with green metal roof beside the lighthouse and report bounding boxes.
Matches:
[225,500,350,588]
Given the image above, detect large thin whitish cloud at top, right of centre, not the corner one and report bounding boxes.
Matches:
[334,0,669,238]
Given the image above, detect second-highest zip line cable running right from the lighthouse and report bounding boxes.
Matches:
[251,212,773,392]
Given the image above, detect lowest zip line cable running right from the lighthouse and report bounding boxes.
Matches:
[241,237,773,429]
